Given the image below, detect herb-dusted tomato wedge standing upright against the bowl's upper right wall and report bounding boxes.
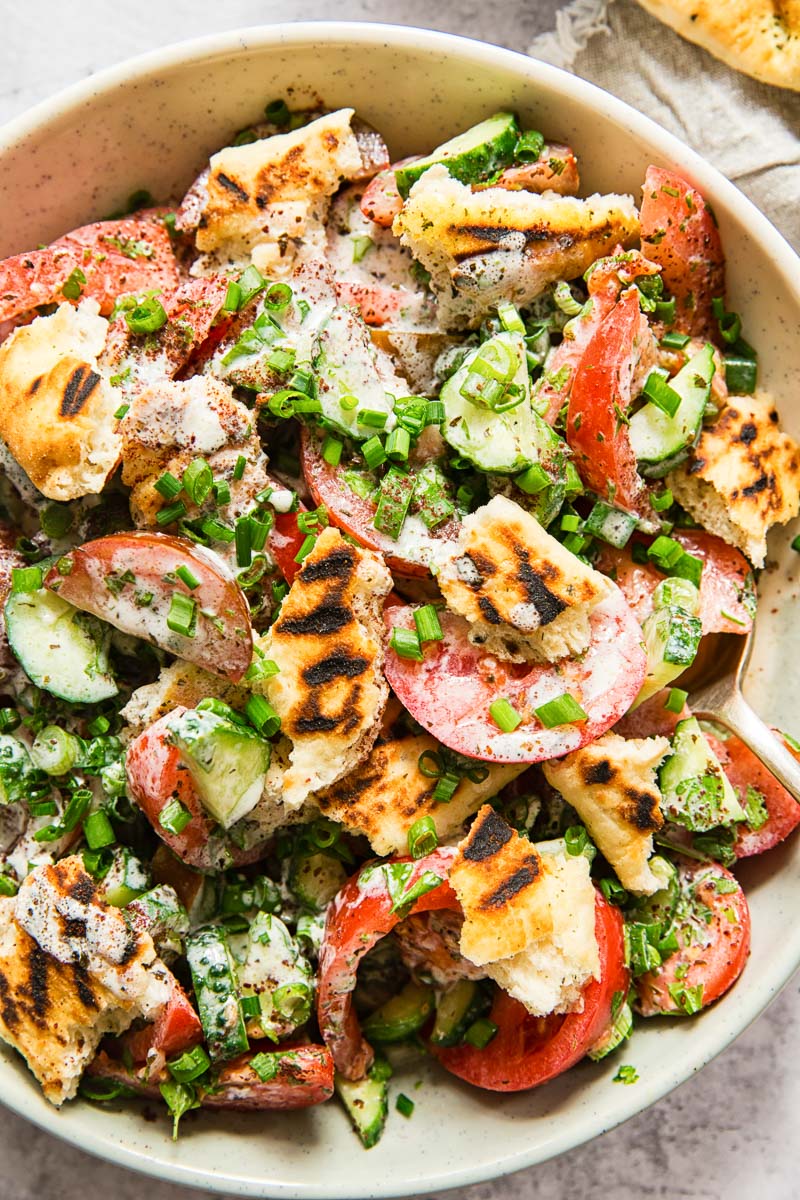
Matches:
[639,167,724,341]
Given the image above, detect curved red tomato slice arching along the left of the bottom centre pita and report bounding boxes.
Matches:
[317,846,461,1079]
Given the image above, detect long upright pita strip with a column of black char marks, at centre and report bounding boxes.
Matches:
[257,528,392,809]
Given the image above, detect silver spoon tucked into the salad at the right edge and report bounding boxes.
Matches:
[680,626,800,803]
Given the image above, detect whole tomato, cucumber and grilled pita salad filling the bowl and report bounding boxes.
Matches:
[0,100,800,1147]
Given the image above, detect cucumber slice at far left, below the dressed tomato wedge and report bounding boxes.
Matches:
[5,588,119,704]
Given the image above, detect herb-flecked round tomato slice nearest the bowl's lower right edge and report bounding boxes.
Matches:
[636,863,750,1016]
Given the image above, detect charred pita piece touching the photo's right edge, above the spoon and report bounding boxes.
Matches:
[667,391,800,566]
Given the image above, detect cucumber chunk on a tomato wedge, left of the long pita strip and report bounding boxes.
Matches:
[168,709,270,829]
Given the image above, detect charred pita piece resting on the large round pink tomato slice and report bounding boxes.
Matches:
[437,496,610,662]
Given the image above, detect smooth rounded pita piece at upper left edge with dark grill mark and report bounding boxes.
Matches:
[0,300,120,500]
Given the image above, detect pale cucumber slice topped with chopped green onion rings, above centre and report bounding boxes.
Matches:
[439,332,560,475]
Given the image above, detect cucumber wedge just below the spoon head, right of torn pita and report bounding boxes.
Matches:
[658,716,746,833]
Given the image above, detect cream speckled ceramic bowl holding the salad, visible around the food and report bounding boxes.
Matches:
[0,23,800,1200]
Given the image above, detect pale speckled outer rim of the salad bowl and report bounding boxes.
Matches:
[0,22,800,1200]
